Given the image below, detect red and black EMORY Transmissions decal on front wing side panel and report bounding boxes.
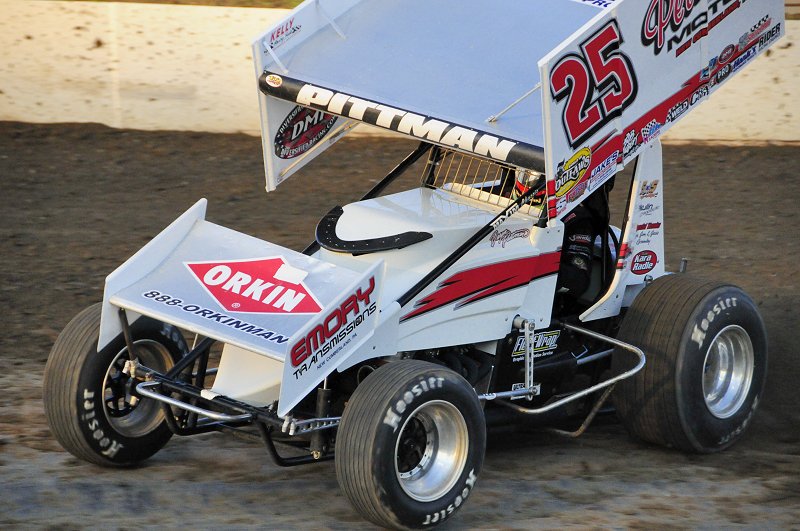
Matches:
[290,277,378,380]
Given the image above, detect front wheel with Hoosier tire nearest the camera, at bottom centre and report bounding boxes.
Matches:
[336,360,486,529]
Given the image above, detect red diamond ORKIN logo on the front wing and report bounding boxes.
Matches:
[186,256,322,315]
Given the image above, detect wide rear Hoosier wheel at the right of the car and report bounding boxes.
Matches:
[612,274,767,453]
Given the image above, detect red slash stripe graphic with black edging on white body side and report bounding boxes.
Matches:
[400,252,561,322]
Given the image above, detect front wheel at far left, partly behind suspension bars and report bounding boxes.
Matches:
[43,304,187,466]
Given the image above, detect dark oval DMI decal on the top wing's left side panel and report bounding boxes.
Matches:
[274,105,337,159]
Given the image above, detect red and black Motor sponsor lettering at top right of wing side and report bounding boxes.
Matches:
[641,0,742,57]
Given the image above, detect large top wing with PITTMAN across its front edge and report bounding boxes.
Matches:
[254,0,785,206]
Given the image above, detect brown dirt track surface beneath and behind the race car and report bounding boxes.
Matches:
[0,122,800,529]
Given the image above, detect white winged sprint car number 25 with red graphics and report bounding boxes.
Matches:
[44,0,784,528]
